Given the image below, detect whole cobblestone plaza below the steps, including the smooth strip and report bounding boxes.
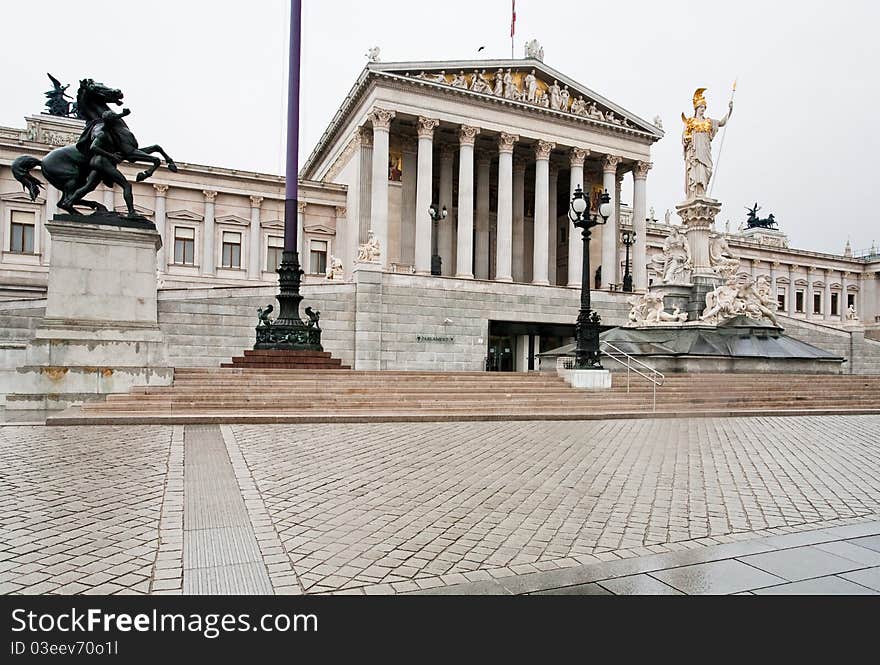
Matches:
[0,416,880,594]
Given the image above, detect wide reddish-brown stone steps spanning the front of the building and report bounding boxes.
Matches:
[49,368,880,424]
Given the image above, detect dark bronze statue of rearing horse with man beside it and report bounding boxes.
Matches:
[12,79,177,217]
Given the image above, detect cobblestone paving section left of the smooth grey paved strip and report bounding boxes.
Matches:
[0,426,172,594]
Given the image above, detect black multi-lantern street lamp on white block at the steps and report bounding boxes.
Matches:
[568,185,611,369]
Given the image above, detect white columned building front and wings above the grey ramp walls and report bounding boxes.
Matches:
[0,60,880,334]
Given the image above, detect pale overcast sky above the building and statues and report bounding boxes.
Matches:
[0,0,880,252]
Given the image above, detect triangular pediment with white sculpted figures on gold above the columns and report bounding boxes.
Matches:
[367,59,663,140]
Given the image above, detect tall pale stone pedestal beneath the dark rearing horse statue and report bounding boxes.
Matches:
[6,215,174,409]
